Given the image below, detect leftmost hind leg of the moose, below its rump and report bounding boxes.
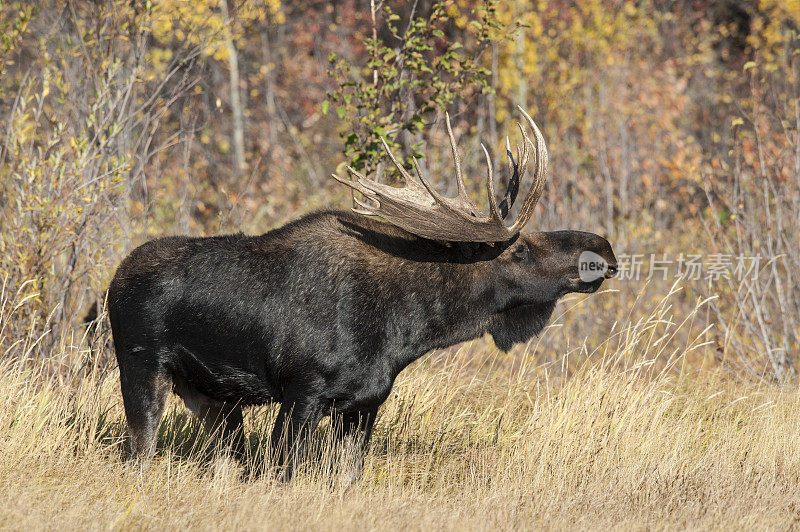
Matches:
[119,361,172,460]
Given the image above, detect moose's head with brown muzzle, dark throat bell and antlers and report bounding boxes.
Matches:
[333,107,617,349]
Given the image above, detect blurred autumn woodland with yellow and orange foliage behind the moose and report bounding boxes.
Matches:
[0,0,800,384]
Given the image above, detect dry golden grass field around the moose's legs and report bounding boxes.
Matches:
[0,286,800,529]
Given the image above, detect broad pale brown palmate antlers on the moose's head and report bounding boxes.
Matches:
[333,106,548,242]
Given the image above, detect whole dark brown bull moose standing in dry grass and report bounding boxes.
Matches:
[108,108,616,478]
